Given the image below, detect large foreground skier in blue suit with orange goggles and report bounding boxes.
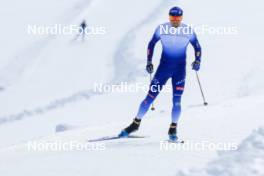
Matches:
[119,7,201,141]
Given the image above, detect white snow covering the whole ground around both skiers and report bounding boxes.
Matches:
[0,0,264,176]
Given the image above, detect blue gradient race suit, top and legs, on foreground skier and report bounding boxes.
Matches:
[136,23,201,123]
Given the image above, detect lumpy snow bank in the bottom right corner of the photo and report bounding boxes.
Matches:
[178,127,264,176]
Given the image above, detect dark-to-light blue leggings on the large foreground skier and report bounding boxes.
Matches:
[136,64,185,123]
